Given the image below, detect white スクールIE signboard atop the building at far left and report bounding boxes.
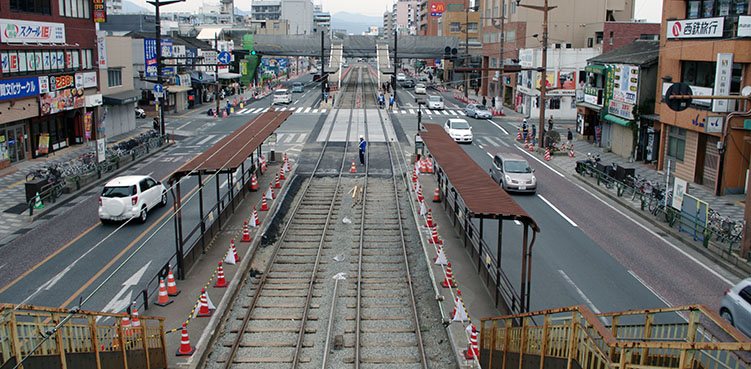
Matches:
[0,19,65,44]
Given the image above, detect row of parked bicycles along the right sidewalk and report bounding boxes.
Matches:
[576,154,746,245]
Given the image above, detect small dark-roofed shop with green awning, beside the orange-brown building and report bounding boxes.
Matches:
[576,40,660,162]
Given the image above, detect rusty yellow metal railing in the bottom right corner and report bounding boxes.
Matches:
[480,305,751,369]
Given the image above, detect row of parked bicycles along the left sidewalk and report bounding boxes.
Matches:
[26,129,163,198]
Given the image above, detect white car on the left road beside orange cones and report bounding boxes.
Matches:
[99,175,167,223]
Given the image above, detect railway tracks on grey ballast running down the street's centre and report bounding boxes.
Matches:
[205,64,446,368]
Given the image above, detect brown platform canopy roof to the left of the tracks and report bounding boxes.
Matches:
[172,111,292,178]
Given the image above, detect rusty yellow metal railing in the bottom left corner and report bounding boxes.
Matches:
[0,304,167,369]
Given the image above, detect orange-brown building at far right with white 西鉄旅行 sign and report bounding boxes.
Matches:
[654,0,751,195]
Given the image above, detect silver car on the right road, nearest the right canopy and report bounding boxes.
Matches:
[490,153,537,193]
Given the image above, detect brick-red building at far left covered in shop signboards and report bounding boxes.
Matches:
[0,0,103,166]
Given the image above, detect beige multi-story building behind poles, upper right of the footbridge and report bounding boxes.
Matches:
[481,0,634,106]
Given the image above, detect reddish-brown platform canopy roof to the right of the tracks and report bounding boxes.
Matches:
[420,123,539,231]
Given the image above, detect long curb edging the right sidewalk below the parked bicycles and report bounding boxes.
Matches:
[573,175,751,278]
